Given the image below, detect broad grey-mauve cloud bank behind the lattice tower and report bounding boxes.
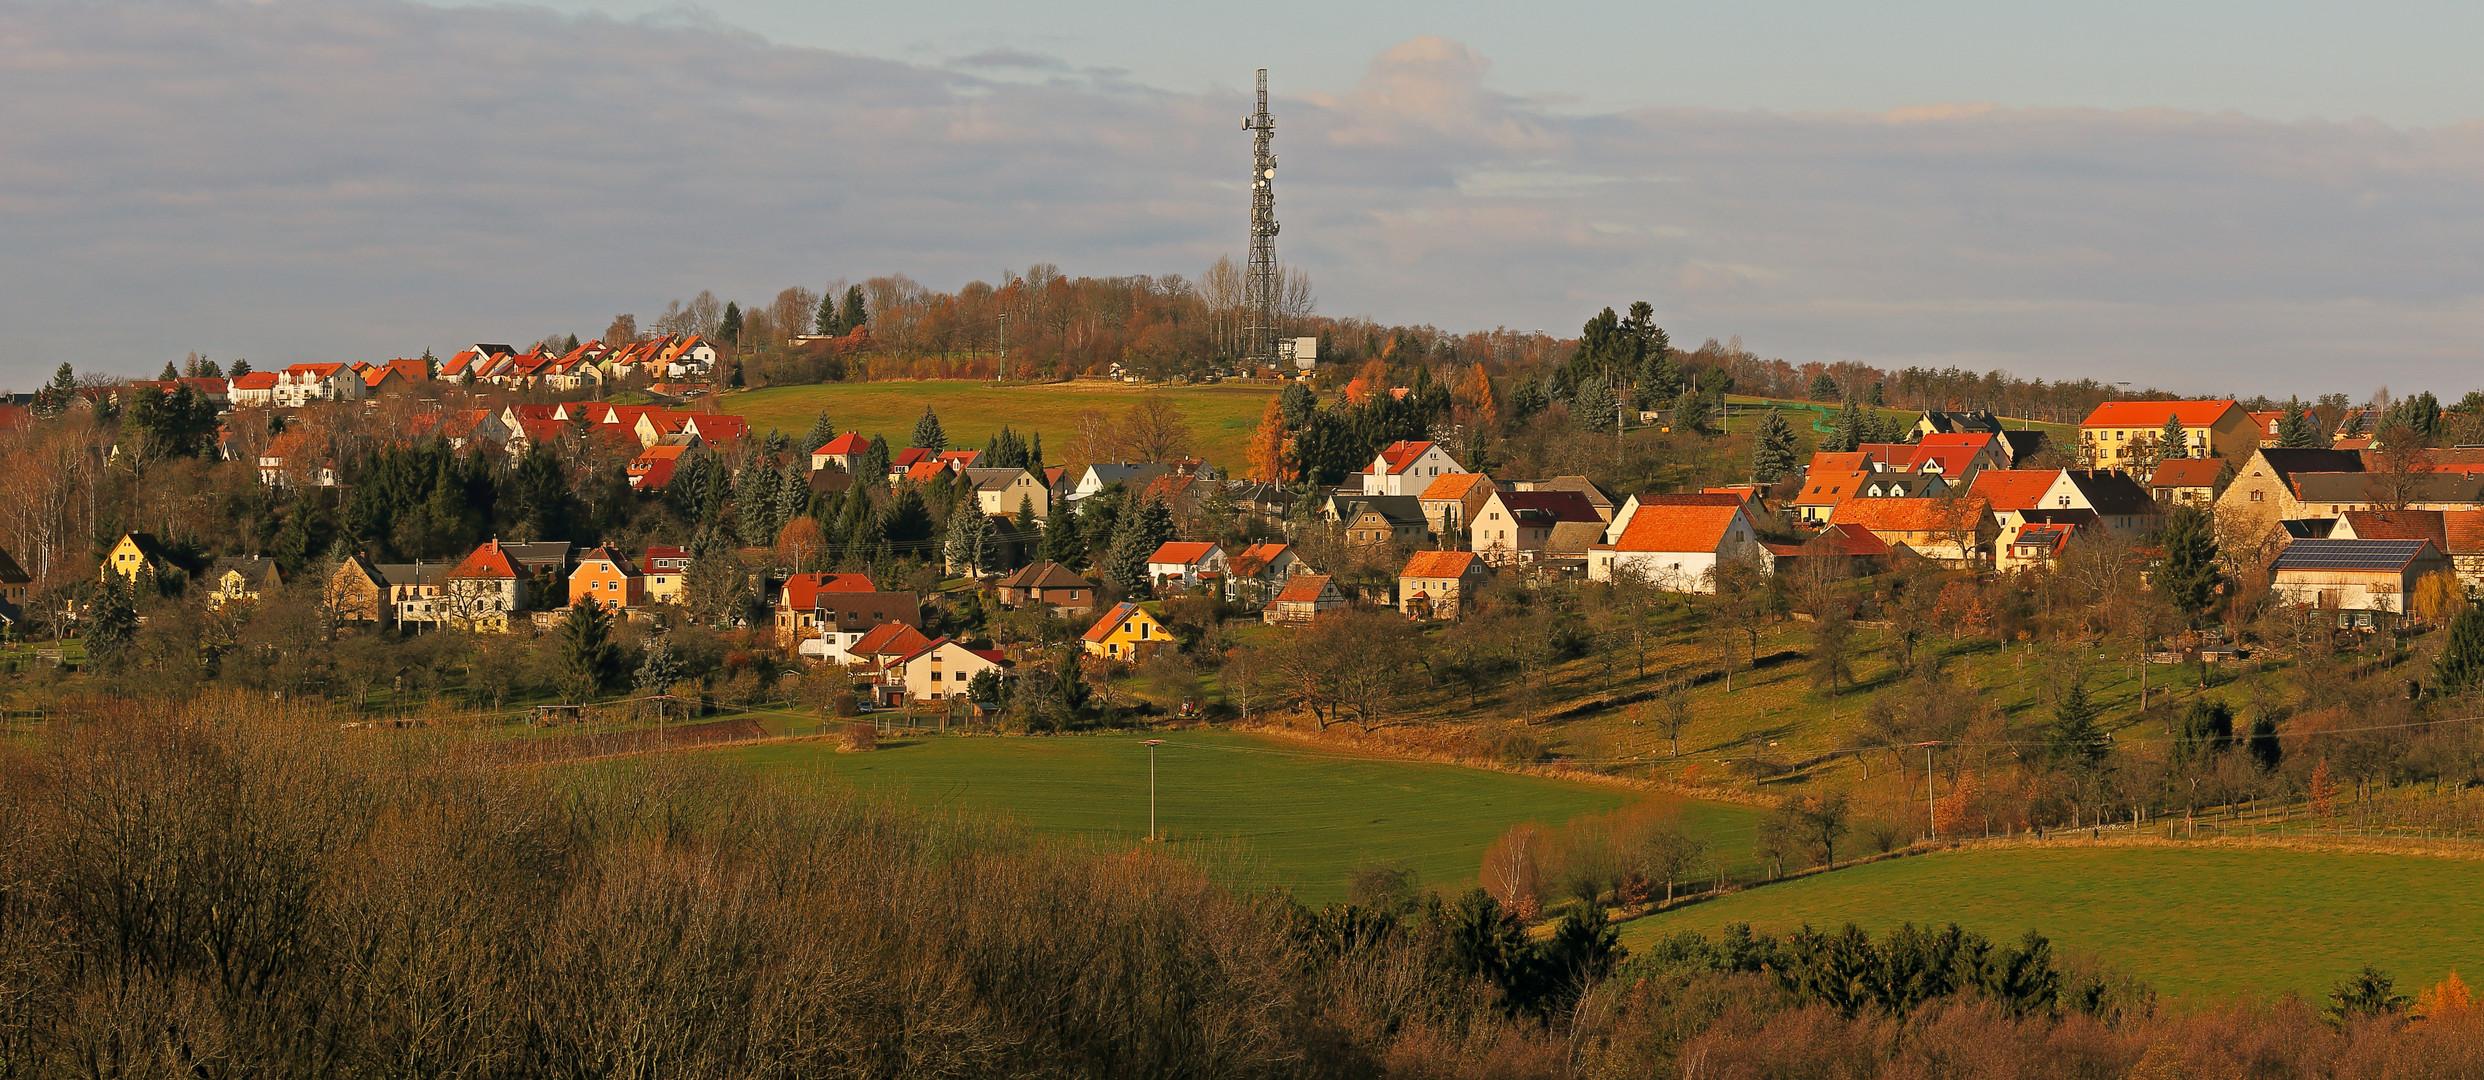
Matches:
[0,0,2484,392]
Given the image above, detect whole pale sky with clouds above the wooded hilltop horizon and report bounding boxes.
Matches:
[0,0,2484,397]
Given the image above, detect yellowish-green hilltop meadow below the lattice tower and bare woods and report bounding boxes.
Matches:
[715,380,1277,469]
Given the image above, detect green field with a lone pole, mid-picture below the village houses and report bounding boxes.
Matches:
[718,732,1756,904]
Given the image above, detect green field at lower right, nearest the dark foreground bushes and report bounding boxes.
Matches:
[1622,847,2484,1001]
